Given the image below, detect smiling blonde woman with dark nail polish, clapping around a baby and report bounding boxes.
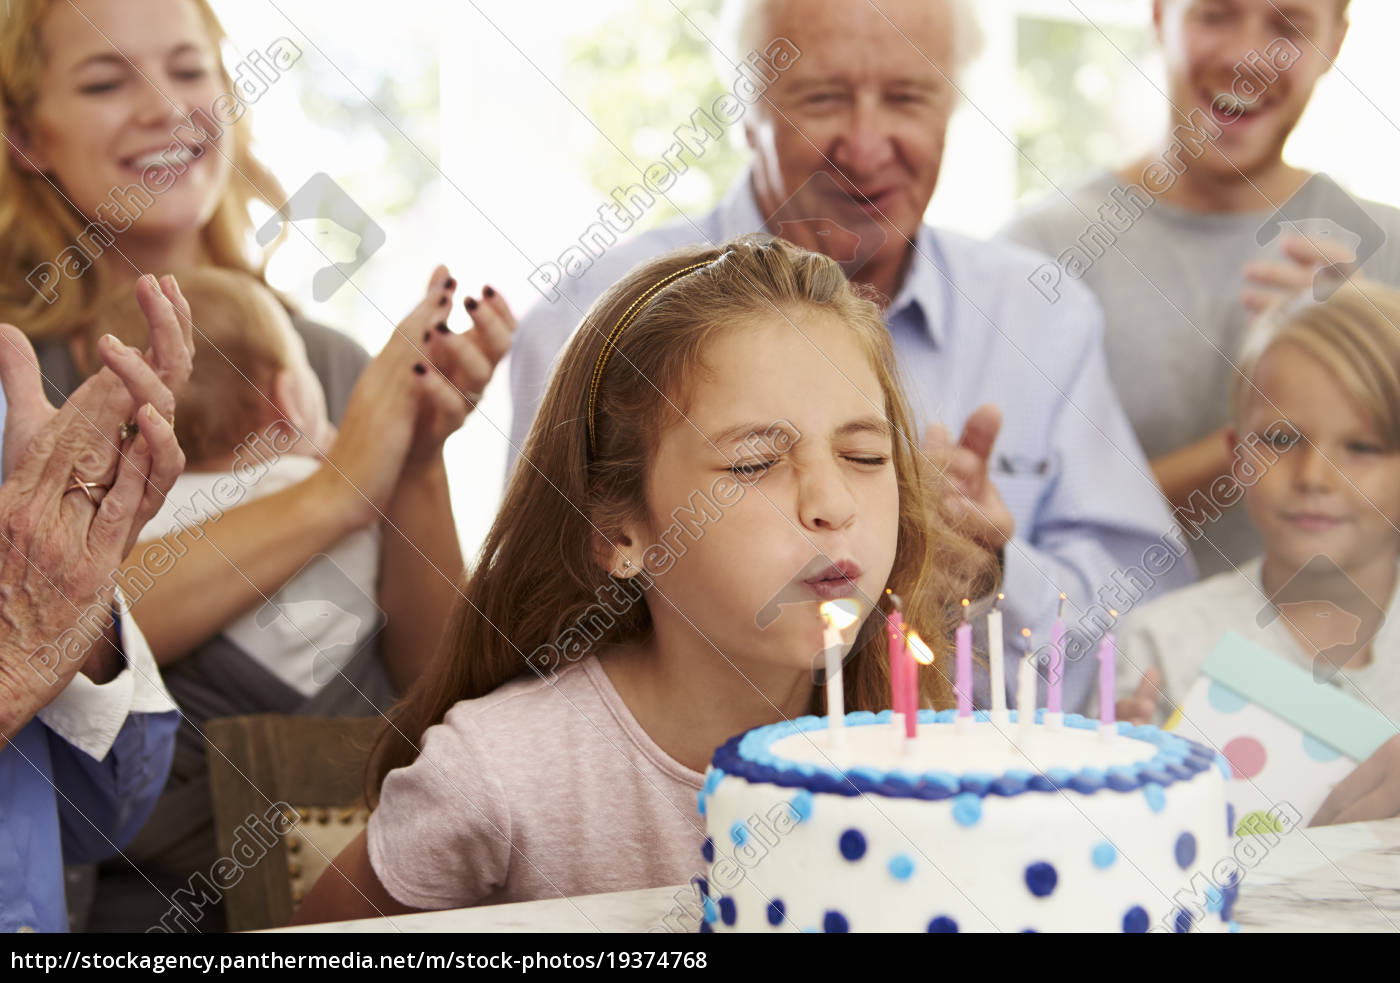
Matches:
[0,0,514,930]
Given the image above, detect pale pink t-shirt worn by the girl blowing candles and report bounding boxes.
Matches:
[368,655,704,909]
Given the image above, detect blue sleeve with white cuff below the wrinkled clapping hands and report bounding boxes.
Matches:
[0,393,179,933]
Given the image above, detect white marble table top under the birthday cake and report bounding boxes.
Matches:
[277,818,1400,933]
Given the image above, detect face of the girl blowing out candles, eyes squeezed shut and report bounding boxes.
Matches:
[630,307,899,686]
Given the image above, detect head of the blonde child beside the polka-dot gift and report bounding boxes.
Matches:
[1231,281,1400,582]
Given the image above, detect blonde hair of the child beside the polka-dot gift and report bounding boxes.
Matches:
[1231,280,1400,449]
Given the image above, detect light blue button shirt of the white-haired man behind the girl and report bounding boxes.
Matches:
[510,176,1196,711]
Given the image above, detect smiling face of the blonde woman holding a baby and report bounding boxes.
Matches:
[11,0,232,245]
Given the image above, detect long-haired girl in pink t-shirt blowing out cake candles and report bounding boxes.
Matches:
[297,237,984,921]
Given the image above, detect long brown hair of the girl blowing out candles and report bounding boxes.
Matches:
[368,235,994,801]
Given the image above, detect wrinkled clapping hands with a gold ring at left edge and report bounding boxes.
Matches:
[0,277,193,738]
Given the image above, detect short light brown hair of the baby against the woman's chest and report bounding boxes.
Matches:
[101,266,291,465]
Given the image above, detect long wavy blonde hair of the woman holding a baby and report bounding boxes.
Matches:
[0,0,287,339]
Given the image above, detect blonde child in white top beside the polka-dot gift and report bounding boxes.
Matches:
[1119,281,1400,822]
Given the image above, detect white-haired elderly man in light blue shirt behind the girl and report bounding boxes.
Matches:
[511,0,1194,710]
